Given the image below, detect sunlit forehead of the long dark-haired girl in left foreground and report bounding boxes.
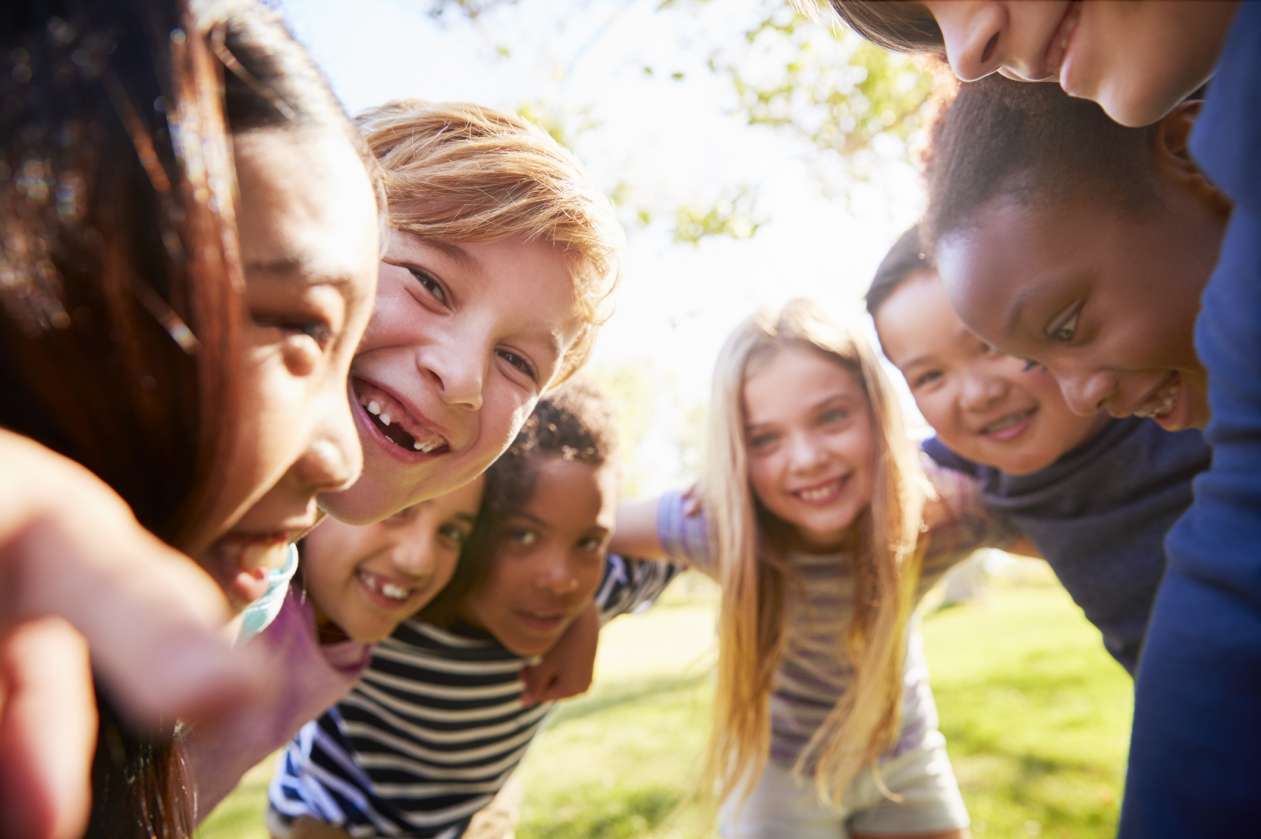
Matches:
[233,130,377,297]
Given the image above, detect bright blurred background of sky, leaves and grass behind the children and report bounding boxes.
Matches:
[199,0,1131,839]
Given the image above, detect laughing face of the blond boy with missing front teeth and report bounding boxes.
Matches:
[320,231,583,522]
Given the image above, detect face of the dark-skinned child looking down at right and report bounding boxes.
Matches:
[936,193,1221,430]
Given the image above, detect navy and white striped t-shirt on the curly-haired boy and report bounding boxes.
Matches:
[267,555,680,839]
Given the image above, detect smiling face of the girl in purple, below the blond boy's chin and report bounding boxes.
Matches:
[301,477,484,643]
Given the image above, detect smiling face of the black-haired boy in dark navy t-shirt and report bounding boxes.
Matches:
[875,270,1106,474]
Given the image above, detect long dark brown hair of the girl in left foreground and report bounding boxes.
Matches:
[0,0,362,839]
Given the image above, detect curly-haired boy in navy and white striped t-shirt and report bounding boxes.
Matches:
[267,384,676,839]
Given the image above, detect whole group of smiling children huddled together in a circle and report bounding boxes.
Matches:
[0,0,1261,839]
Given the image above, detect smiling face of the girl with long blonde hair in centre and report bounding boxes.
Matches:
[741,344,878,550]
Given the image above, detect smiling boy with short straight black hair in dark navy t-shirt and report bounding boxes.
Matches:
[866,226,1209,675]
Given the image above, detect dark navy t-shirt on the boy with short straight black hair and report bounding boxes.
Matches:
[924,419,1208,674]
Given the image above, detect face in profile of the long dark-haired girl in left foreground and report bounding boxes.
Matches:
[190,130,378,606]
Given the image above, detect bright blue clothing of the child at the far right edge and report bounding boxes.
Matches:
[1121,3,1261,839]
